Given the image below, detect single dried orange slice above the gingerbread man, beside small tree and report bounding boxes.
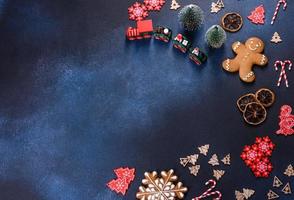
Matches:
[221,13,243,33]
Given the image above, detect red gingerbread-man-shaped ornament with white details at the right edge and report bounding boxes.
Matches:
[276,105,294,136]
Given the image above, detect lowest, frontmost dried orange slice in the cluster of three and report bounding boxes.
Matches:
[243,102,266,125]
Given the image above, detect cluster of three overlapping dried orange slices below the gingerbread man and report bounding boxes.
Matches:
[237,88,275,125]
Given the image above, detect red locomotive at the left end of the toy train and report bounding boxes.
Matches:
[126,20,153,40]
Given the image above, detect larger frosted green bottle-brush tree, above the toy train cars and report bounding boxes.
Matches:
[178,4,204,31]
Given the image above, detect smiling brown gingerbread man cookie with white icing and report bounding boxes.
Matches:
[223,37,268,83]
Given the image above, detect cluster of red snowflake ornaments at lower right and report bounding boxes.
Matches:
[241,136,275,177]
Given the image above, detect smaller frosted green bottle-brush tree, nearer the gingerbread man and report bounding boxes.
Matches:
[205,25,227,49]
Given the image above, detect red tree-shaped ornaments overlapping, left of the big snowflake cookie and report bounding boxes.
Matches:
[107,167,135,195]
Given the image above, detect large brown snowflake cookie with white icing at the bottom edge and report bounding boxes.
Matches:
[136,169,188,200]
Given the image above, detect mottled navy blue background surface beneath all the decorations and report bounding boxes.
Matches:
[0,0,294,200]
